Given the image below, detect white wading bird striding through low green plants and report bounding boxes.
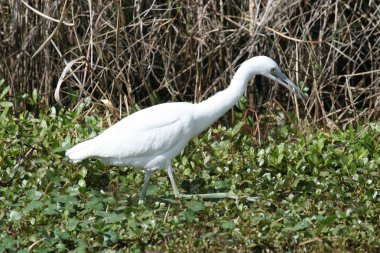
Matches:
[66,56,307,201]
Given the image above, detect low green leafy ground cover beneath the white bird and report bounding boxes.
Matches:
[0,98,380,252]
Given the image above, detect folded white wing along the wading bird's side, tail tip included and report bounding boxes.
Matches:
[67,103,192,160]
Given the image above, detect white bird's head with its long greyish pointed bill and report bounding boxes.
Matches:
[246,56,307,101]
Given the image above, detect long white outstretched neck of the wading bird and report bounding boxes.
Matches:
[195,59,260,133]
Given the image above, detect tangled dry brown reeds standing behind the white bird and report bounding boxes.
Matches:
[0,0,380,126]
